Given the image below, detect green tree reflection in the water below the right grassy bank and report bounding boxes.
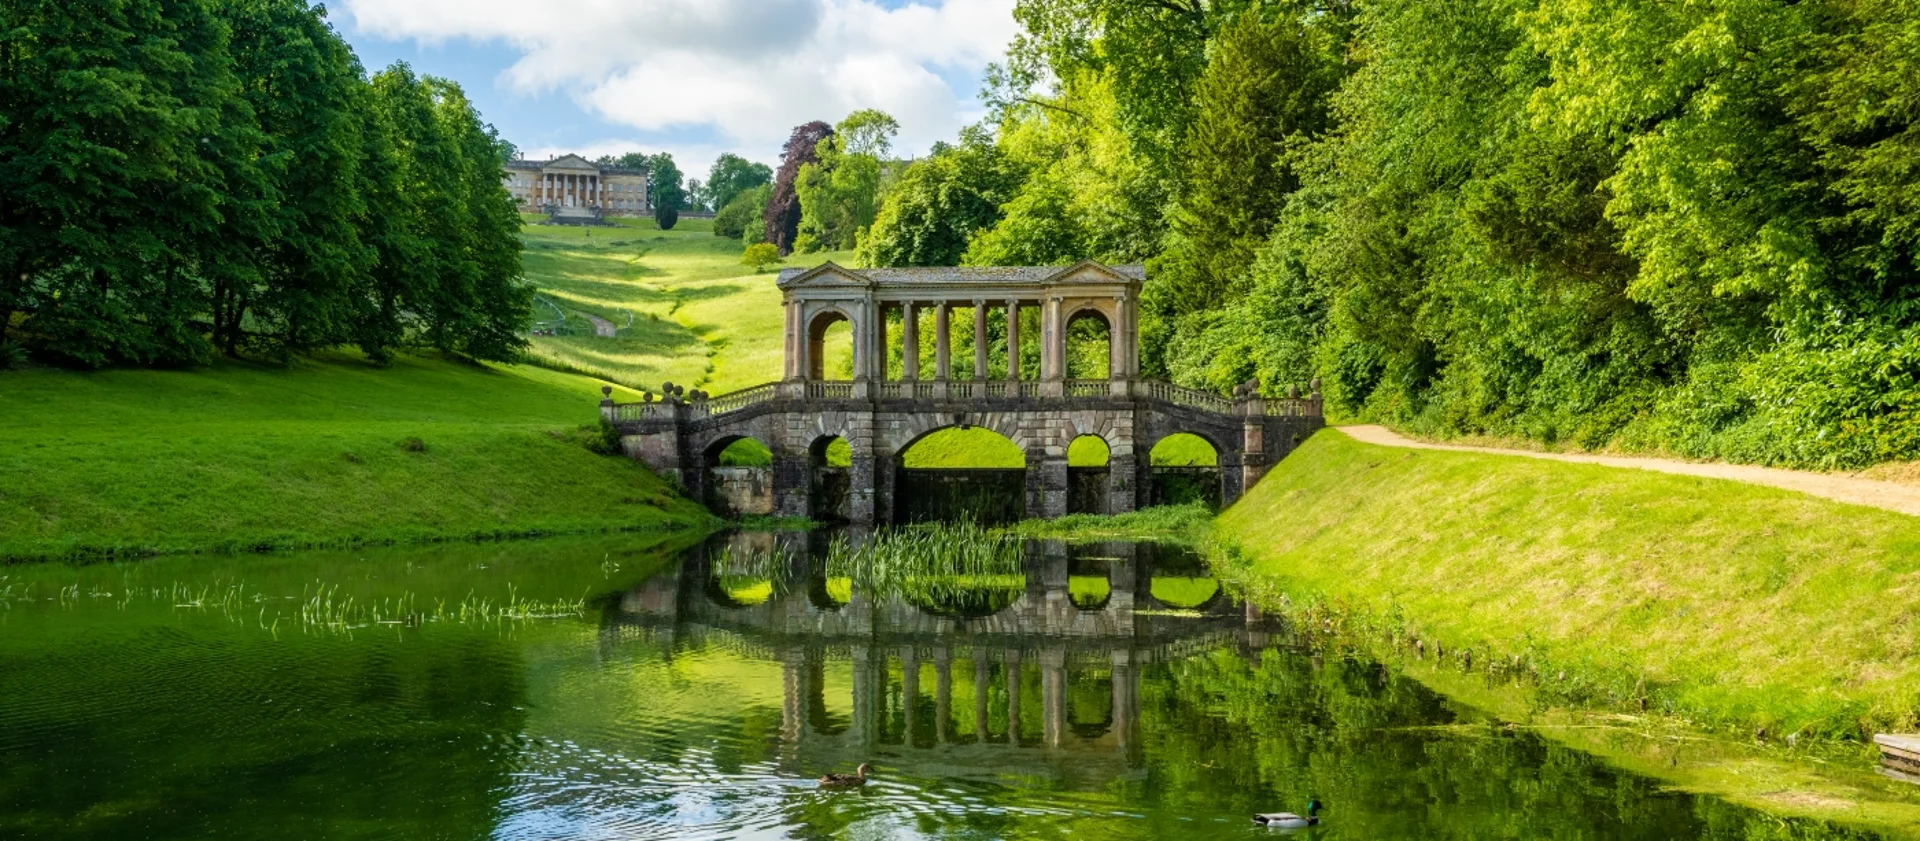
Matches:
[1140,651,1872,839]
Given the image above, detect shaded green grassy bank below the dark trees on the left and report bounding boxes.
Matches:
[0,355,707,561]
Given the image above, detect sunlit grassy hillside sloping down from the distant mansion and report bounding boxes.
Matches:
[522,217,852,394]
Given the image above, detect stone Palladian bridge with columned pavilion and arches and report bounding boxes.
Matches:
[601,261,1323,524]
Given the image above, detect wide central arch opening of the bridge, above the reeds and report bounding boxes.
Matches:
[893,424,1027,524]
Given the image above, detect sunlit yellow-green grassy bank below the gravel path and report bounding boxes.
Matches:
[1215,430,1920,739]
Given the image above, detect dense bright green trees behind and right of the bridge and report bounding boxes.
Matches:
[858,0,1920,467]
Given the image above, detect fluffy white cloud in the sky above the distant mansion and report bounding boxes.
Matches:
[346,0,1016,159]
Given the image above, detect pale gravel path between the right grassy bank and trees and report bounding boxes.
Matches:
[1336,426,1920,517]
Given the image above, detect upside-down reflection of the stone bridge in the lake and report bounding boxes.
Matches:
[605,534,1269,781]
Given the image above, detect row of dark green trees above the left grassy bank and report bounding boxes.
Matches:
[0,0,532,367]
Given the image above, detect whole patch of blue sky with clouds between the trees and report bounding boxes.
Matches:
[330,0,1016,179]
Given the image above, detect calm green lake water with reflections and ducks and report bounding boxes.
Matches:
[0,534,1870,841]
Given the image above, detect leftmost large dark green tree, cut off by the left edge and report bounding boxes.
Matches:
[0,0,247,365]
